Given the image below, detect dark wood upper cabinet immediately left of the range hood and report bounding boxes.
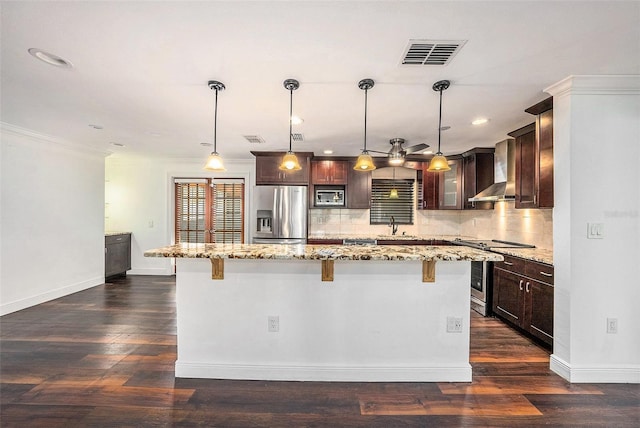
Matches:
[462,148,495,210]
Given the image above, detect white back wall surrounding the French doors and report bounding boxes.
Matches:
[104,153,255,275]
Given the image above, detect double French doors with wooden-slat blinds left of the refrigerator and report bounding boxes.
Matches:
[175,178,244,244]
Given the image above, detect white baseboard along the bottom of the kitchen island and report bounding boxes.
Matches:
[175,361,471,382]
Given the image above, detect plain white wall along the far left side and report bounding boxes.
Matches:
[0,124,104,315]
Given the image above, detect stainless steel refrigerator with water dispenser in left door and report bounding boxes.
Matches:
[253,186,309,244]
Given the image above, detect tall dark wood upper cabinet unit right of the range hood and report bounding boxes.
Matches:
[509,97,553,208]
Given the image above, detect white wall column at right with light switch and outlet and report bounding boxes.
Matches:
[547,76,640,383]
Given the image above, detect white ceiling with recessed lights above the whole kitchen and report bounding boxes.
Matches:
[1,1,640,162]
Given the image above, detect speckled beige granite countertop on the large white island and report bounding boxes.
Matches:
[144,244,503,261]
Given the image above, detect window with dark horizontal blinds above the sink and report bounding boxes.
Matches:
[369,179,415,224]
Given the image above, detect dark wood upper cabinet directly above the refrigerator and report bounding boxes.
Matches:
[251,151,313,185]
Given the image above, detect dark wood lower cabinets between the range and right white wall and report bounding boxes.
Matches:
[492,256,554,346]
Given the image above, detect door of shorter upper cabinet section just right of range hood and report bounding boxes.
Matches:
[515,130,537,208]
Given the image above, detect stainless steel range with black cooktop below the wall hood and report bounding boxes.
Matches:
[452,238,535,317]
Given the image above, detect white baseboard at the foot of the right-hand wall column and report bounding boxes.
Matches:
[549,355,640,383]
